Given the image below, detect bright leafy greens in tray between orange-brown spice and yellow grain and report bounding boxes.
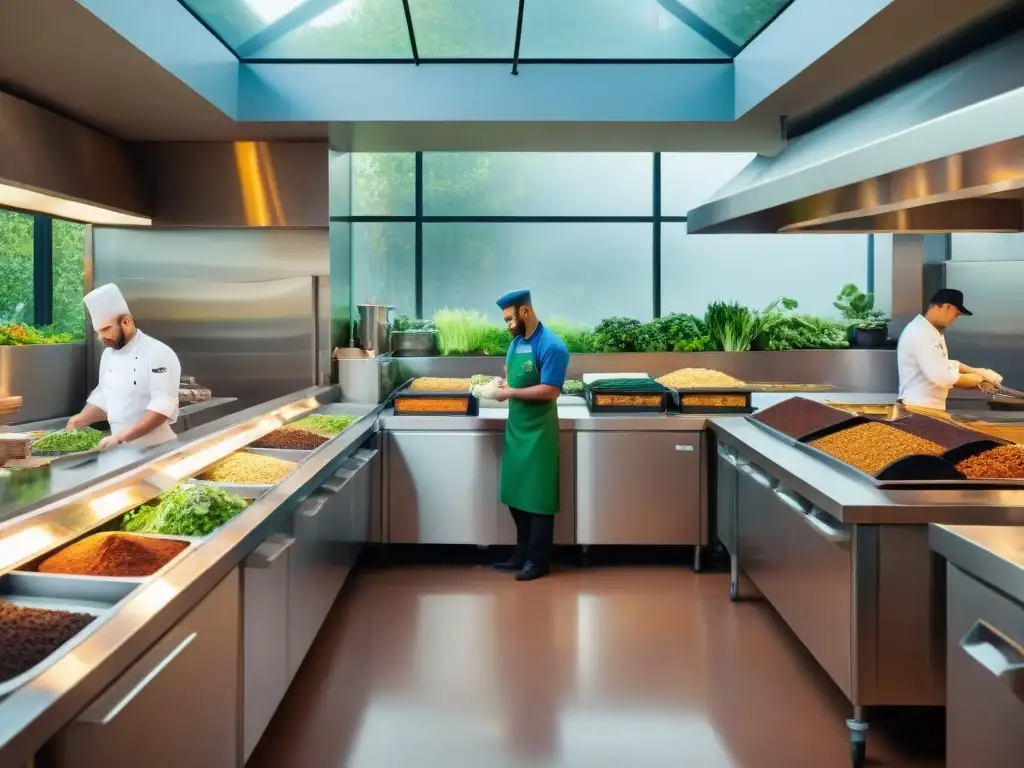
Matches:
[121,485,246,536]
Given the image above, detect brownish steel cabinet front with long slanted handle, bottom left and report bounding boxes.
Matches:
[53,569,241,768]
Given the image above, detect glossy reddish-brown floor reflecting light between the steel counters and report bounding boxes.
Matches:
[249,566,943,768]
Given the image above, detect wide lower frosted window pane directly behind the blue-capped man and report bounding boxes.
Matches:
[423,222,653,325]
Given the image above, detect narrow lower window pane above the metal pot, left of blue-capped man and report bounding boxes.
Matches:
[351,221,416,314]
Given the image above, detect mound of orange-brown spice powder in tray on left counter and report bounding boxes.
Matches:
[39,531,188,577]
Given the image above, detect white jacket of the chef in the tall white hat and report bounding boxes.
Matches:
[88,330,181,447]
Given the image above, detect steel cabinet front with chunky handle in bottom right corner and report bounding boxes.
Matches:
[946,564,1024,768]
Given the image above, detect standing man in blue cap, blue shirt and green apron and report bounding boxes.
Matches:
[495,291,569,582]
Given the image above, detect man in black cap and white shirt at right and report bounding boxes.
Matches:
[896,288,1002,412]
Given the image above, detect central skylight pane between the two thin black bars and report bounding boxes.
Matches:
[407,0,520,58]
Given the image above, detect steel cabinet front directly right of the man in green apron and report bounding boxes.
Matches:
[577,431,705,545]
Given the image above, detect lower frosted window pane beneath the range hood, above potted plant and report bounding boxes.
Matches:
[662,223,867,315]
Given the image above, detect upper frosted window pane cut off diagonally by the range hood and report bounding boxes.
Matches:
[662,152,756,216]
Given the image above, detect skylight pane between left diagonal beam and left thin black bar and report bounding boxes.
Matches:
[245,0,413,59]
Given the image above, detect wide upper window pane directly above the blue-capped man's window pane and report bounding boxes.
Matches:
[423,152,653,217]
